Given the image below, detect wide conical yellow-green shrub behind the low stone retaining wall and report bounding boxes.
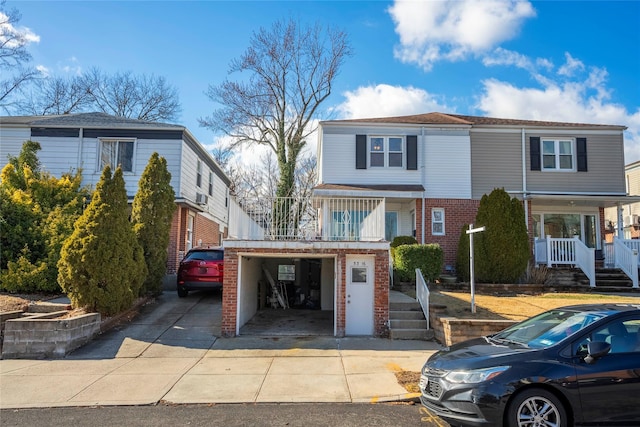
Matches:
[58,166,146,316]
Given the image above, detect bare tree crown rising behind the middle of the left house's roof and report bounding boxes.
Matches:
[82,68,181,121]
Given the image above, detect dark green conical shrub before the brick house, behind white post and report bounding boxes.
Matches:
[474,188,530,283]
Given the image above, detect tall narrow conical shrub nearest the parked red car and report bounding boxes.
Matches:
[131,153,176,295]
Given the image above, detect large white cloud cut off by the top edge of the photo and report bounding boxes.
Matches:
[388,0,535,71]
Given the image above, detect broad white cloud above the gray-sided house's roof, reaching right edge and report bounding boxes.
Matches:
[477,54,640,163]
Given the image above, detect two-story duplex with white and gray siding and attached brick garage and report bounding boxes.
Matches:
[223,113,637,335]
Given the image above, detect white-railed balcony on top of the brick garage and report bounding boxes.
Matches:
[229,197,385,241]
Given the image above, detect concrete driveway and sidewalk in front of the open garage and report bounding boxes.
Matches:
[0,292,440,409]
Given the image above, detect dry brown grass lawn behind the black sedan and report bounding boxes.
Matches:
[429,291,640,320]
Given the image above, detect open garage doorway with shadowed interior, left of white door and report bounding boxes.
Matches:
[238,257,335,336]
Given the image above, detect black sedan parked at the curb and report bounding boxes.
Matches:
[420,304,640,427]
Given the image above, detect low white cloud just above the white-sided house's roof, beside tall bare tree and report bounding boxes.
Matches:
[336,84,452,119]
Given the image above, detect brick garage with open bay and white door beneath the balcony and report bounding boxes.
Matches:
[221,240,389,337]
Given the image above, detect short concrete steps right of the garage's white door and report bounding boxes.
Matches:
[389,291,431,340]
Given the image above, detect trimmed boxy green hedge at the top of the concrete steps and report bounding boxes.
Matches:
[395,243,444,282]
